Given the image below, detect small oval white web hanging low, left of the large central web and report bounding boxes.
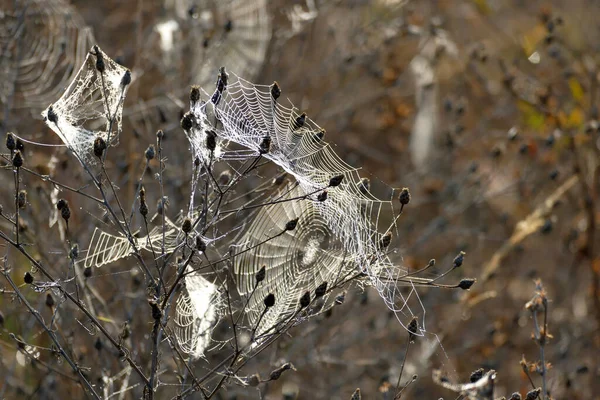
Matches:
[173,267,221,359]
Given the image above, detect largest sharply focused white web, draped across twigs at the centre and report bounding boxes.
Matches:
[193,76,432,331]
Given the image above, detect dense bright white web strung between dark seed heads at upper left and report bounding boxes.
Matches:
[42,46,131,165]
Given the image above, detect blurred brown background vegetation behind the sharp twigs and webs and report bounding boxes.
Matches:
[0,0,600,399]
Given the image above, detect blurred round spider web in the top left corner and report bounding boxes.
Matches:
[0,0,93,112]
